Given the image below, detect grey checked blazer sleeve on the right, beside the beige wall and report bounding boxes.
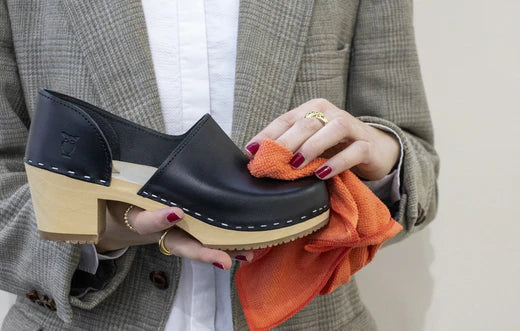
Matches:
[346,0,439,245]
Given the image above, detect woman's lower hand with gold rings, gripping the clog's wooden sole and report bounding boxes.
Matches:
[96,201,253,270]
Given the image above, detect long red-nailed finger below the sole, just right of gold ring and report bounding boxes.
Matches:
[164,228,232,270]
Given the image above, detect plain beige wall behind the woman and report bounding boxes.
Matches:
[0,0,520,331]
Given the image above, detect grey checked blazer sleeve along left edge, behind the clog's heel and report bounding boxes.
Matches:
[0,1,135,322]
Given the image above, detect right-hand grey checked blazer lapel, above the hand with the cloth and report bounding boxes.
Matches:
[231,0,314,147]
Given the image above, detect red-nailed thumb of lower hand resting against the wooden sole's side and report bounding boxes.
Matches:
[128,206,184,235]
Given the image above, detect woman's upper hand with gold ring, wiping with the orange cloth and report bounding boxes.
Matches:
[246,99,400,180]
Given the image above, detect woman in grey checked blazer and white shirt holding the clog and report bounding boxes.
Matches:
[0,0,438,330]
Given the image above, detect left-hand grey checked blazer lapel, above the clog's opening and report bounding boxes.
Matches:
[64,0,165,132]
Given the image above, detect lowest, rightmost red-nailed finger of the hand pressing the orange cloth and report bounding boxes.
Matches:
[316,140,370,179]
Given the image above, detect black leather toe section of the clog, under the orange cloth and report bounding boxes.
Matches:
[138,114,328,231]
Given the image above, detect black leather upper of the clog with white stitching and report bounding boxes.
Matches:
[25,90,329,231]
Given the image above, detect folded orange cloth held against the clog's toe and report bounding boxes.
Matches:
[235,140,402,331]
